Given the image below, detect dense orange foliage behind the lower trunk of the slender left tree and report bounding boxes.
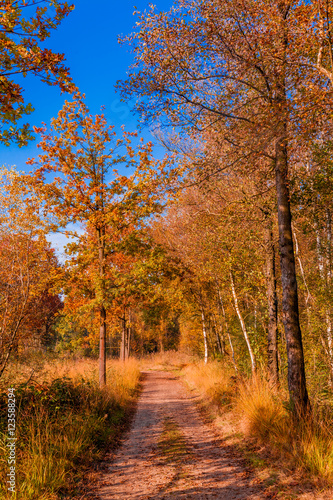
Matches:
[63,215,158,359]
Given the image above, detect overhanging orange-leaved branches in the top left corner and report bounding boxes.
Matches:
[0,0,74,146]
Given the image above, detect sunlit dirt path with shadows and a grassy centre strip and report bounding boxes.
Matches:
[94,372,267,500]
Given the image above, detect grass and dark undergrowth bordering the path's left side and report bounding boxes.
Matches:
[0,360,140,500]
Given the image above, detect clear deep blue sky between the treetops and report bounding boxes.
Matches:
[0,0,173,171]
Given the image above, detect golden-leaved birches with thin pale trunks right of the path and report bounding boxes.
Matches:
[153,168,272,372]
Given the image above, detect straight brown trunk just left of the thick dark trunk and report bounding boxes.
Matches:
[266,222,279,383]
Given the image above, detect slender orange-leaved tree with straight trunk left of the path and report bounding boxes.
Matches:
[29,95,166,386]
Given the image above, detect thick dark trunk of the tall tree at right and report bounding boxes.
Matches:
[274,9,310,418]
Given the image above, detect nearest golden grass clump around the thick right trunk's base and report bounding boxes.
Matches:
[235,375,333,485]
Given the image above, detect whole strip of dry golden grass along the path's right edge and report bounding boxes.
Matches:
[183,362,333,490]
